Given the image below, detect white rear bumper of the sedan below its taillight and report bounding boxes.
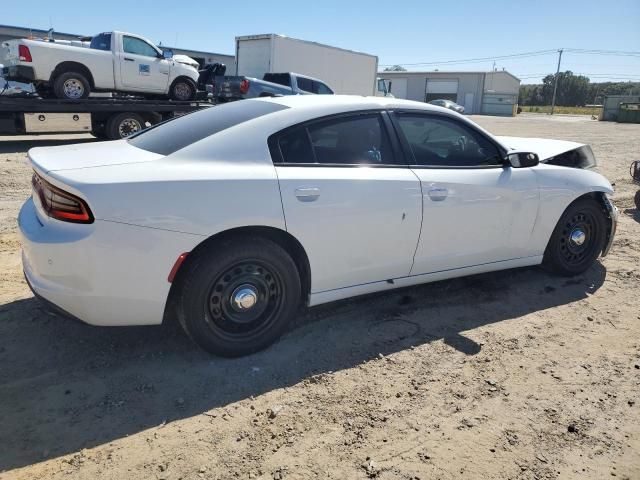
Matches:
[18,198,199,326]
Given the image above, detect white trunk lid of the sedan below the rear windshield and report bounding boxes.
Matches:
[28,140,164,174]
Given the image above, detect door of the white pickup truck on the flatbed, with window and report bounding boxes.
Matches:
[116,35,171,92]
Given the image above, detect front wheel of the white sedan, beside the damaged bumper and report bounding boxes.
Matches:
[542,198,607,277]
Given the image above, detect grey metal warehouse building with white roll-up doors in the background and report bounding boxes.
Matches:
[378,70,520,115]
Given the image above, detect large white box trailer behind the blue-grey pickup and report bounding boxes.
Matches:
[236,33,378,95]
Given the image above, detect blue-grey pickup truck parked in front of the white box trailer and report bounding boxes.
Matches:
[213,73,333,101]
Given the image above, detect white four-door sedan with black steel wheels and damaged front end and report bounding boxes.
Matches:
[19,95,617,356]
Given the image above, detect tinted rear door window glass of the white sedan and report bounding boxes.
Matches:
[278,114,394,165]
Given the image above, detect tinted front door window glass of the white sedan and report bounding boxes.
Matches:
[397,114,503,167]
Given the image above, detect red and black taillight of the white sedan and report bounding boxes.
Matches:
[31,173,93,223]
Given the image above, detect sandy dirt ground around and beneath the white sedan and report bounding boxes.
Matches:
[0,115,640,480]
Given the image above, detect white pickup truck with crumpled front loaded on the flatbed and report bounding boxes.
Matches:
[0,32,198,101]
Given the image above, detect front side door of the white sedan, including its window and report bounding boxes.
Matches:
[395,112,539,274]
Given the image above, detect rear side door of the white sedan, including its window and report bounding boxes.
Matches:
[269,112,421,293]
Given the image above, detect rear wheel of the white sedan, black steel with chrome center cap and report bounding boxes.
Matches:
[178,237,301,357]
